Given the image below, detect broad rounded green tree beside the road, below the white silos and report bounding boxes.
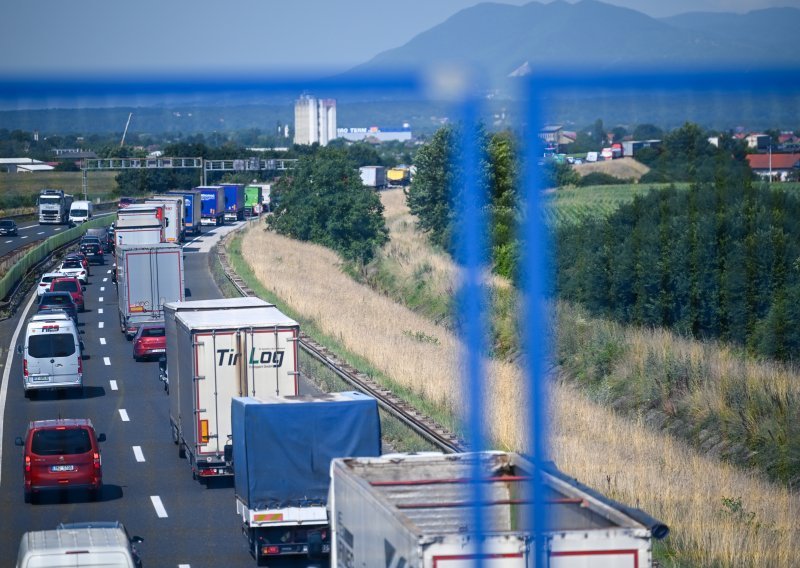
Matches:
[268,148,389,263]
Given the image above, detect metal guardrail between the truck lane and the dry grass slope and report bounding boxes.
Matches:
[216,243,467,453]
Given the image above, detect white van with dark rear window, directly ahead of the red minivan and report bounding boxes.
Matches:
[17,310,83,398]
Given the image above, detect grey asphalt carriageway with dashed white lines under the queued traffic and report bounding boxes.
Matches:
[0,221,319,568]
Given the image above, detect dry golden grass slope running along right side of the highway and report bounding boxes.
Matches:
[242,191,800,567]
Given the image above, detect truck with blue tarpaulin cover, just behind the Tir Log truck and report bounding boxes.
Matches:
[231,392,384,566]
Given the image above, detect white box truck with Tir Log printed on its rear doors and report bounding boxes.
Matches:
[164,298,300,481]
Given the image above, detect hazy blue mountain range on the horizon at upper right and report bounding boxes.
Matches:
[351,0,800,83]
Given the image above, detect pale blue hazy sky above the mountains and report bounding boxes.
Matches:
[0,0,800,77]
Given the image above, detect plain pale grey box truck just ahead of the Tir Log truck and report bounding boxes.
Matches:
[114,243,185,335]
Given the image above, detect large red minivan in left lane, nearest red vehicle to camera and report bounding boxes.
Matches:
[14,418,106,503]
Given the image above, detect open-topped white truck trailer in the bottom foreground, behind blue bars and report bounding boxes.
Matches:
[328,452,669,568]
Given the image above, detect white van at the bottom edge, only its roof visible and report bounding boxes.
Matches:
[16,522,142,568]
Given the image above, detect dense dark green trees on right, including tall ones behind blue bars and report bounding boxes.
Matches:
[407,124,800,360]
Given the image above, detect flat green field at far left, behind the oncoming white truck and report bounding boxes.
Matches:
[0,172,117,216]
